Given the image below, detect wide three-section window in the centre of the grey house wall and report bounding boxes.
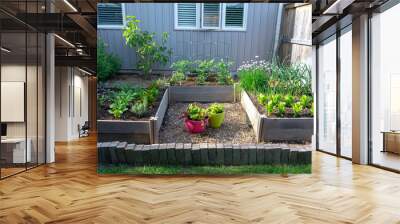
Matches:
[175,3,247,31]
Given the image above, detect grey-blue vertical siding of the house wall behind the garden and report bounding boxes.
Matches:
[98,3,279,71]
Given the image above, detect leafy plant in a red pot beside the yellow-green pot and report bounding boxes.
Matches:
[184,104,208,133]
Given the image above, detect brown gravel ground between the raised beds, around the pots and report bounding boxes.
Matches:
[160,103,257,144]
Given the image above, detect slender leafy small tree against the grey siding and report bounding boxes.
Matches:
[123,16,172,76]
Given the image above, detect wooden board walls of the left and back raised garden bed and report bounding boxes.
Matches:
[97,86,239,144]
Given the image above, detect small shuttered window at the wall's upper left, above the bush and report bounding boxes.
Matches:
[97,3,125,28]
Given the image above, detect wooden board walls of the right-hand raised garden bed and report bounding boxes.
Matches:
[241,91,314,142]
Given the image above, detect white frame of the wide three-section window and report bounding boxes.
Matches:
[174,3,248,31]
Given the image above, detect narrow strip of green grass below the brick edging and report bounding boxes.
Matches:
[98,165,311,175]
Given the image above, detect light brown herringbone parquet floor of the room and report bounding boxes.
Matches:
[0,138,400,224]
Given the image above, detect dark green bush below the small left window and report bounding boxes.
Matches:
[97,39,121,82]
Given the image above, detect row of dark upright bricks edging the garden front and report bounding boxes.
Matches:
[97,141,312,166]
